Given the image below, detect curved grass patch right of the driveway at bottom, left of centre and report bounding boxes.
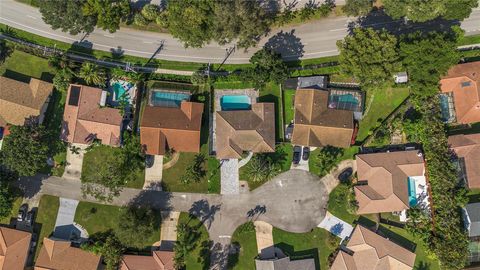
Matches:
[178,212,210,270]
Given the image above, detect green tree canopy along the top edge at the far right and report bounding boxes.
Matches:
[382,0,478,22]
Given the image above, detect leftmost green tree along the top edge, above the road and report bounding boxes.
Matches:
[38,0,96,35]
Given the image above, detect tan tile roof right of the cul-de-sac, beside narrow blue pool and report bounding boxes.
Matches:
[354,150,424,214]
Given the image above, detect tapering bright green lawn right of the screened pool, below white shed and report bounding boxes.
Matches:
[356,87,409,142]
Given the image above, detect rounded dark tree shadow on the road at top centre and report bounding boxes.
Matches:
[264,29,305,65]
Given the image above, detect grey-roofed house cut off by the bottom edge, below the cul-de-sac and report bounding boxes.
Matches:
[255,257,315,270]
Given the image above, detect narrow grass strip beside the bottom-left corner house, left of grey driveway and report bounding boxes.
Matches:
[35,195,60,258]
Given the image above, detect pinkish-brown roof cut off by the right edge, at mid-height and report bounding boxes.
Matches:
[448,133,480,188]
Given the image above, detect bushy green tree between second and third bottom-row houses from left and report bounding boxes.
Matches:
[81,231,125,270]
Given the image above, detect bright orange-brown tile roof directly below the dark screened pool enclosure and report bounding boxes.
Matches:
[140,101,203,155]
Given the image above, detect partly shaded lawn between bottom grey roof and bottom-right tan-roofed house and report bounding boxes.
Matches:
[273,227,340,270]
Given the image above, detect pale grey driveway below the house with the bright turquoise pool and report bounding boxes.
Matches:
[220,158,240,195]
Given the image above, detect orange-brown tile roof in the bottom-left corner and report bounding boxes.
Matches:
[0,227,32,270]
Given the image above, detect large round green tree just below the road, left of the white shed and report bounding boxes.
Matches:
[337,28,401,86]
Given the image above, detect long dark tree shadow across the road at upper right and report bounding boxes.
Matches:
[348,8,460,36]
